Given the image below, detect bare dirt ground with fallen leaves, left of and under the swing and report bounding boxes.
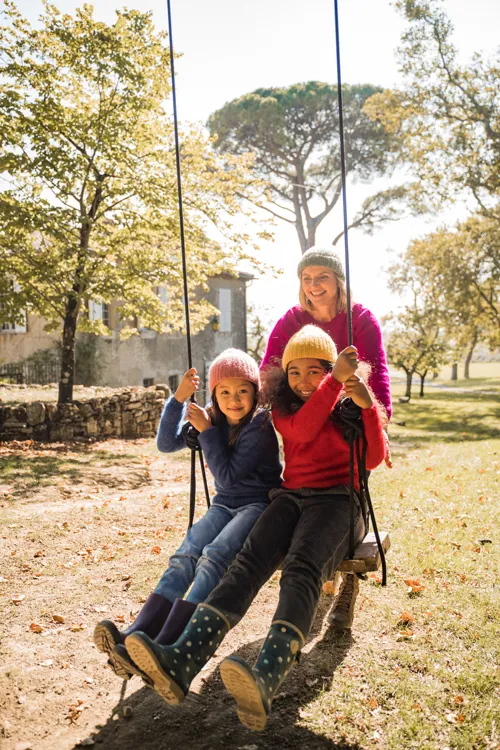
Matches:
[0,441,362,750]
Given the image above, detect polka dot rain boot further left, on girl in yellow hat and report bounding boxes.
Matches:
[125,604,230,706]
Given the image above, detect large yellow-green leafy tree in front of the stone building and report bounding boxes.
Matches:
[0,0,260,401]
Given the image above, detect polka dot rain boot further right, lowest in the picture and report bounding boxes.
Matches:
[220,620,304,732]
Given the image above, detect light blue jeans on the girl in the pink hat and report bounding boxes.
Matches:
[155,502,268,604]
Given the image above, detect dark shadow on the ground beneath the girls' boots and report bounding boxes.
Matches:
[74,597,360,750]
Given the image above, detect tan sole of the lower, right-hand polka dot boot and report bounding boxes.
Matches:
[220,659,268,732]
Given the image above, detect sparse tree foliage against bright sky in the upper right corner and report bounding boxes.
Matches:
[365,0,500,221]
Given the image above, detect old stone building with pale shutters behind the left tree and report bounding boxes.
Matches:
[0,272,253,400]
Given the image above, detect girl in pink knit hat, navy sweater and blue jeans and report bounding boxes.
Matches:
[94,349,281,680]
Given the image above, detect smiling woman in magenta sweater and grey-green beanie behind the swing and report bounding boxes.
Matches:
[260,247,392,630]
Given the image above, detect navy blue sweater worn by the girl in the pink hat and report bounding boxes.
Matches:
[156,396,281,508]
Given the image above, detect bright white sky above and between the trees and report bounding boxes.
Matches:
[13,0,500,328]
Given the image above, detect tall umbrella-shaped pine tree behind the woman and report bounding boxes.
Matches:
[208,81,404,252]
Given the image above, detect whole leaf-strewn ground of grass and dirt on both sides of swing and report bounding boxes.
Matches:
[0,382,500,750]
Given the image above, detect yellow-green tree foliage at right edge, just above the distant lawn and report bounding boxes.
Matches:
[388,216,500,384]
